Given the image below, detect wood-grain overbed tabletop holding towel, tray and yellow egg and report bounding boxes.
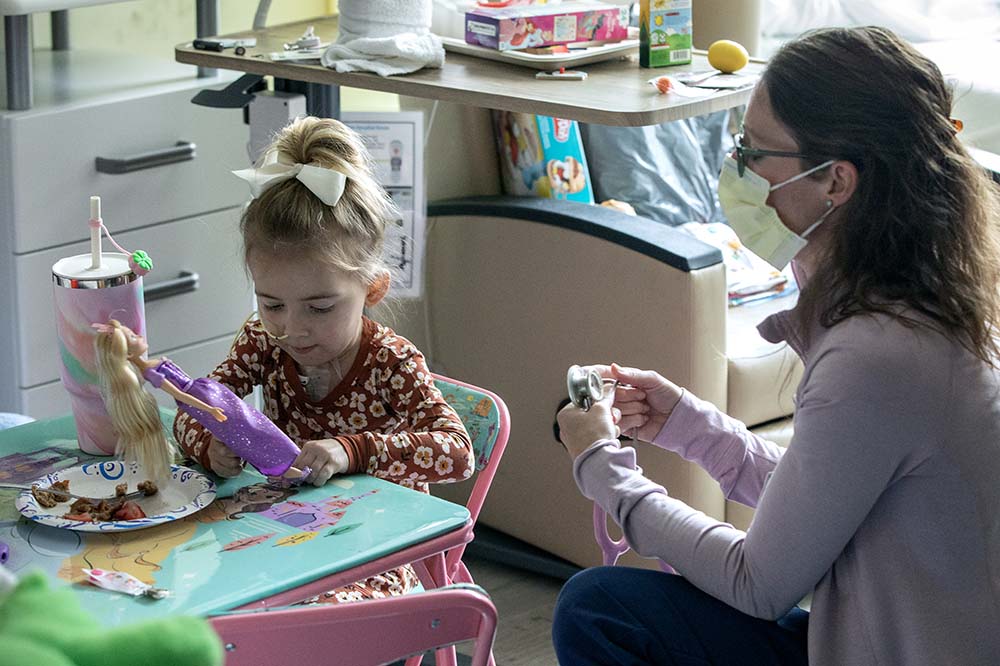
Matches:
[174,17,764,126]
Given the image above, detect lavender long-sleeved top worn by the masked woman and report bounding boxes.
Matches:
[574,312,1000,666]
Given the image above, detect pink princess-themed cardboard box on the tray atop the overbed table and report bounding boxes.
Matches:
[465,2,628,51]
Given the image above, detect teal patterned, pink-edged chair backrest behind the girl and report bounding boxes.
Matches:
[434,374,510,571]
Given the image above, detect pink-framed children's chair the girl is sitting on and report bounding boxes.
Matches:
[398,374,510,666]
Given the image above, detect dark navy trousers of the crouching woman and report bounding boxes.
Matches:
[552,567,809,666]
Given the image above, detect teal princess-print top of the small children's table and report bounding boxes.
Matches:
[0,411,469,625]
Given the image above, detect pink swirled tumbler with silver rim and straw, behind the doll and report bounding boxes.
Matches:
[52,252,146,455]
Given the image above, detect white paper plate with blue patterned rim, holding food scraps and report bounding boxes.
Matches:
[14,460,215,532]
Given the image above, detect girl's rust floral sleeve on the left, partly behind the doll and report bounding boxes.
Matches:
[174,322,266,470]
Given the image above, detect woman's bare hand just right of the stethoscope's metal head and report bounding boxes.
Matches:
[592,363,684,442]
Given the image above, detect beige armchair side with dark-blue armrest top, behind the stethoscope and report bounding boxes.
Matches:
[422,191,727,566]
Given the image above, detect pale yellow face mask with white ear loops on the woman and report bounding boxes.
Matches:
[719,155,834,270]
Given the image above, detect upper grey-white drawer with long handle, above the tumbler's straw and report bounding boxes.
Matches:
[6,81,249,254]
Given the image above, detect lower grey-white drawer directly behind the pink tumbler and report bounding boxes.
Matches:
[14,208,253,388]
